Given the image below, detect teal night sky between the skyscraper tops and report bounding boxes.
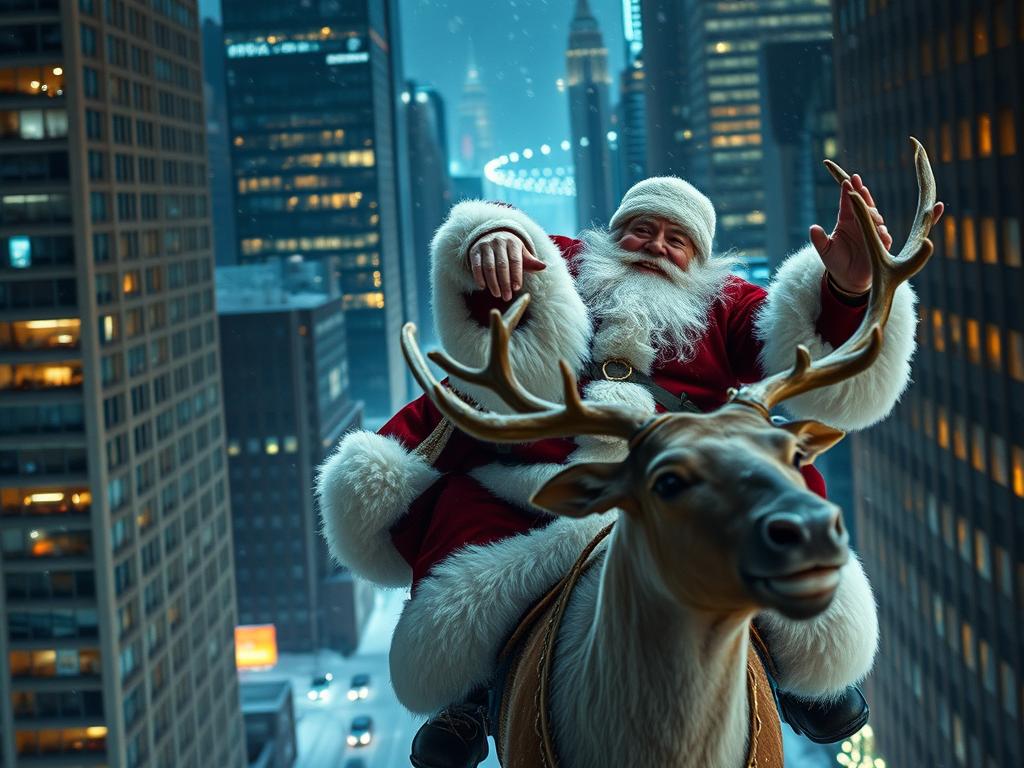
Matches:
[200,0,625,165]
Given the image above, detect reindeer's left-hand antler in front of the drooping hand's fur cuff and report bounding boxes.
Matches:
[401,294,649,442]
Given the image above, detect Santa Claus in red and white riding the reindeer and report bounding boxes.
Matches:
[318,176,942,768]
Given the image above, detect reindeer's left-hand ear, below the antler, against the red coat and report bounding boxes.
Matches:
[531,462,635,517]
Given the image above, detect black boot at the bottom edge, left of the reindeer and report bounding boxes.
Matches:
[409,702,487,768]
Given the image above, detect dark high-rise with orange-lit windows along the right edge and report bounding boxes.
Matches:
[835,0,1024,768]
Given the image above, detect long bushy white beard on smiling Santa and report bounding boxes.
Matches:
[575,229,738,374]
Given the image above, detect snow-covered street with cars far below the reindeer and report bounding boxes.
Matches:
[241,591,838,768]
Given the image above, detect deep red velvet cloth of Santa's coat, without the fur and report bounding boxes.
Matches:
[380,237,864,589]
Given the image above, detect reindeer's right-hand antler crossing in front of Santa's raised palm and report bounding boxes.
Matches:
[732,136,935,416]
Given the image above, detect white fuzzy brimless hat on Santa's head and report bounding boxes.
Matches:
[608,176,715,258]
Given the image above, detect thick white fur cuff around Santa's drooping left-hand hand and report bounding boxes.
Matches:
[431,200,591,413]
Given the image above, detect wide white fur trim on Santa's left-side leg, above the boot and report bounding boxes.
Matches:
[390,512,617,713]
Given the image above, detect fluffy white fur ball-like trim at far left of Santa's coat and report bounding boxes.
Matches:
[316,430,440,587]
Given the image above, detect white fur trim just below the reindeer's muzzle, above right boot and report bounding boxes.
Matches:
[757,553,879,699]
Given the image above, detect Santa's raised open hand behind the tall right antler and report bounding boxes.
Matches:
[810,173,945,296]
